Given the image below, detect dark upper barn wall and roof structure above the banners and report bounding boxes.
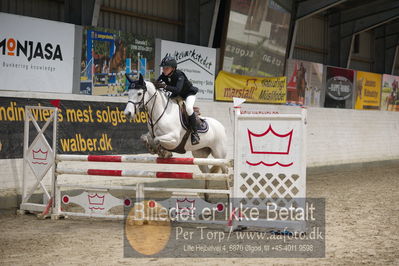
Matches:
[0,0,399,75]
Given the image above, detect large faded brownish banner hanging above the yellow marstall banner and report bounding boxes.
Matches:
[223,0,291,77]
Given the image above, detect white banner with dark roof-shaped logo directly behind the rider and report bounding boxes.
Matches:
[159,40,216,100]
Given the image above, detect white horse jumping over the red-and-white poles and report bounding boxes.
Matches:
[124,75,227,193]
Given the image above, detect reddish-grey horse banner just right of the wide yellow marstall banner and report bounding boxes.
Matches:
[286,59,323,107]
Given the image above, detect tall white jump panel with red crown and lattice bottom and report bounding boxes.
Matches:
[234,110,306,231]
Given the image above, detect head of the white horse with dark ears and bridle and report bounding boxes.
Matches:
[124,74,147,119]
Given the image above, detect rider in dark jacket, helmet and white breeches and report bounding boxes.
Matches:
[155,55,200,145]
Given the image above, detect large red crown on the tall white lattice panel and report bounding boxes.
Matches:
[247,125,294,154]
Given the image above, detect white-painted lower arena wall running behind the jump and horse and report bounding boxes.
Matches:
[0,92,399,208]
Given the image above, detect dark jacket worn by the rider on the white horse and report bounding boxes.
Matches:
[157,69,198,99]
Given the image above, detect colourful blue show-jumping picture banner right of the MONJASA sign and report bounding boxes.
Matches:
[80,27,155,96]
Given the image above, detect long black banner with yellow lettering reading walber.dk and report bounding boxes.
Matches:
[0,97,147,159]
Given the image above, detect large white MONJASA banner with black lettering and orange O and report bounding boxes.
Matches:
[0,13,75,93]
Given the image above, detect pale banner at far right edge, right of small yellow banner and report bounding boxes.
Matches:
[381,74,399,111]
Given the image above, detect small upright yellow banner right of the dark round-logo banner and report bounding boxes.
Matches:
[355,71,382,110]
